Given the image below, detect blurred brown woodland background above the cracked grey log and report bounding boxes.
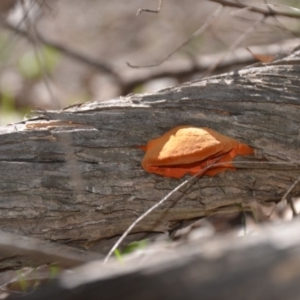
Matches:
[0,0,300,125]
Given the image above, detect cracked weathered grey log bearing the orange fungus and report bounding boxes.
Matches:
[0,52,300,252]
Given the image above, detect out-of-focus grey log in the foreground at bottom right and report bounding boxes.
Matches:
[10,220,300,300]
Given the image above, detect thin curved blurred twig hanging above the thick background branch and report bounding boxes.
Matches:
[127,7,223,68]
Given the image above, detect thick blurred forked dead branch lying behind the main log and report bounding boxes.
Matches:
[4,18,299,95]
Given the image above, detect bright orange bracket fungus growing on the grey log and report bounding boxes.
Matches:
[139,126,254,178]
